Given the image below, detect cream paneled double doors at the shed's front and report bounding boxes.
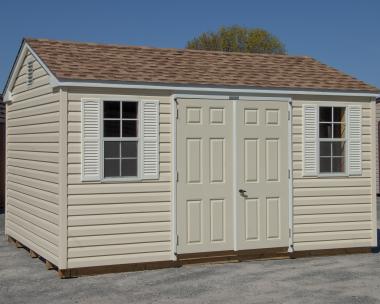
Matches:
[176,99,289,254]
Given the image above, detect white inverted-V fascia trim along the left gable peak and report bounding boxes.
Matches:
[3,41,59,103]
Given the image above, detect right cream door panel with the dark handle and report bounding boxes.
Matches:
[236,101,288,250]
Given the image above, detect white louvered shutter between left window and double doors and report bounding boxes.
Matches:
[141,100,160,179]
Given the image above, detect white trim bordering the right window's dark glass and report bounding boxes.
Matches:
[317,103,349,178]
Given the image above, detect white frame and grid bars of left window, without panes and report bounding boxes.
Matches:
[102,100,140,179]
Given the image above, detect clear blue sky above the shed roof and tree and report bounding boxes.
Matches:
[0,0,380,91]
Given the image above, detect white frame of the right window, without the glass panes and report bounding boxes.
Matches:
[317,103,348,177]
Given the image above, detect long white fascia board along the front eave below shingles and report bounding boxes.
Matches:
[55,80,378,97]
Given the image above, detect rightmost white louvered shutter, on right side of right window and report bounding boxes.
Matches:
[347,105,362,175]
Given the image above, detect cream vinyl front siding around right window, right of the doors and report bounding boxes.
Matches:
[293,99,376,251]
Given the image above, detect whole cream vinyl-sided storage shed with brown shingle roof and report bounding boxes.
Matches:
[4,39,379,275]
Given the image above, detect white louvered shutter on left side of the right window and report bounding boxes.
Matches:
[303,105,318,176]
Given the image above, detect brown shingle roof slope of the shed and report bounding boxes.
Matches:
[26,39,380,92]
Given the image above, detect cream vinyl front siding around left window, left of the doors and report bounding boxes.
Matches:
[68,90,172,268]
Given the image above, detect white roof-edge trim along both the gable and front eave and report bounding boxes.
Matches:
[3,40,380,102]
